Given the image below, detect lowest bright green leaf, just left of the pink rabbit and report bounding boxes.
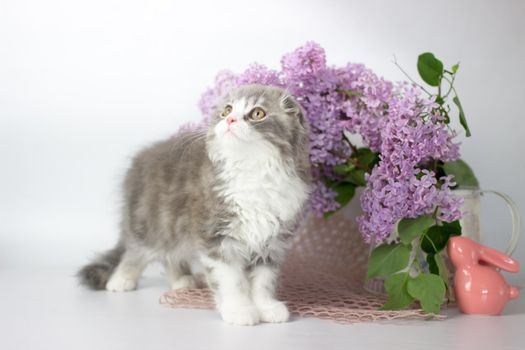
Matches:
[407,273,445,314]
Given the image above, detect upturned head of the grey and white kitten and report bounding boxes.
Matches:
[210,85,307,161]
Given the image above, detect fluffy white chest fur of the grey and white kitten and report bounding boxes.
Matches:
[211,142,308,255]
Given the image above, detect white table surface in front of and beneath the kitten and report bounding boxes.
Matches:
[0,267,525,350]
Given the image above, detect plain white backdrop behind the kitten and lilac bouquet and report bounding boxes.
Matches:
[0,0,525,279]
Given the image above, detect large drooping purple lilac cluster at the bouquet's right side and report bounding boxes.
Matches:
[358,83,461,242]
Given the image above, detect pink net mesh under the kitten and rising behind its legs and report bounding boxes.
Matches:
[160,209,442,324]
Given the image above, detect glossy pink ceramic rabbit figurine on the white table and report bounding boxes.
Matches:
[448,237,520,315]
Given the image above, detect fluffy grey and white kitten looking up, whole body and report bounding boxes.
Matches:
[78,85,310,325]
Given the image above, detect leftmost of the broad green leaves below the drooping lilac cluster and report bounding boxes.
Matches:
[367,244,410,278]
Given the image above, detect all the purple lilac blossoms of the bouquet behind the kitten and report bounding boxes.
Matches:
[199,42,461,241]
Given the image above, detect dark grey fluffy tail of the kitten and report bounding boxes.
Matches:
[77,244,125,290]
